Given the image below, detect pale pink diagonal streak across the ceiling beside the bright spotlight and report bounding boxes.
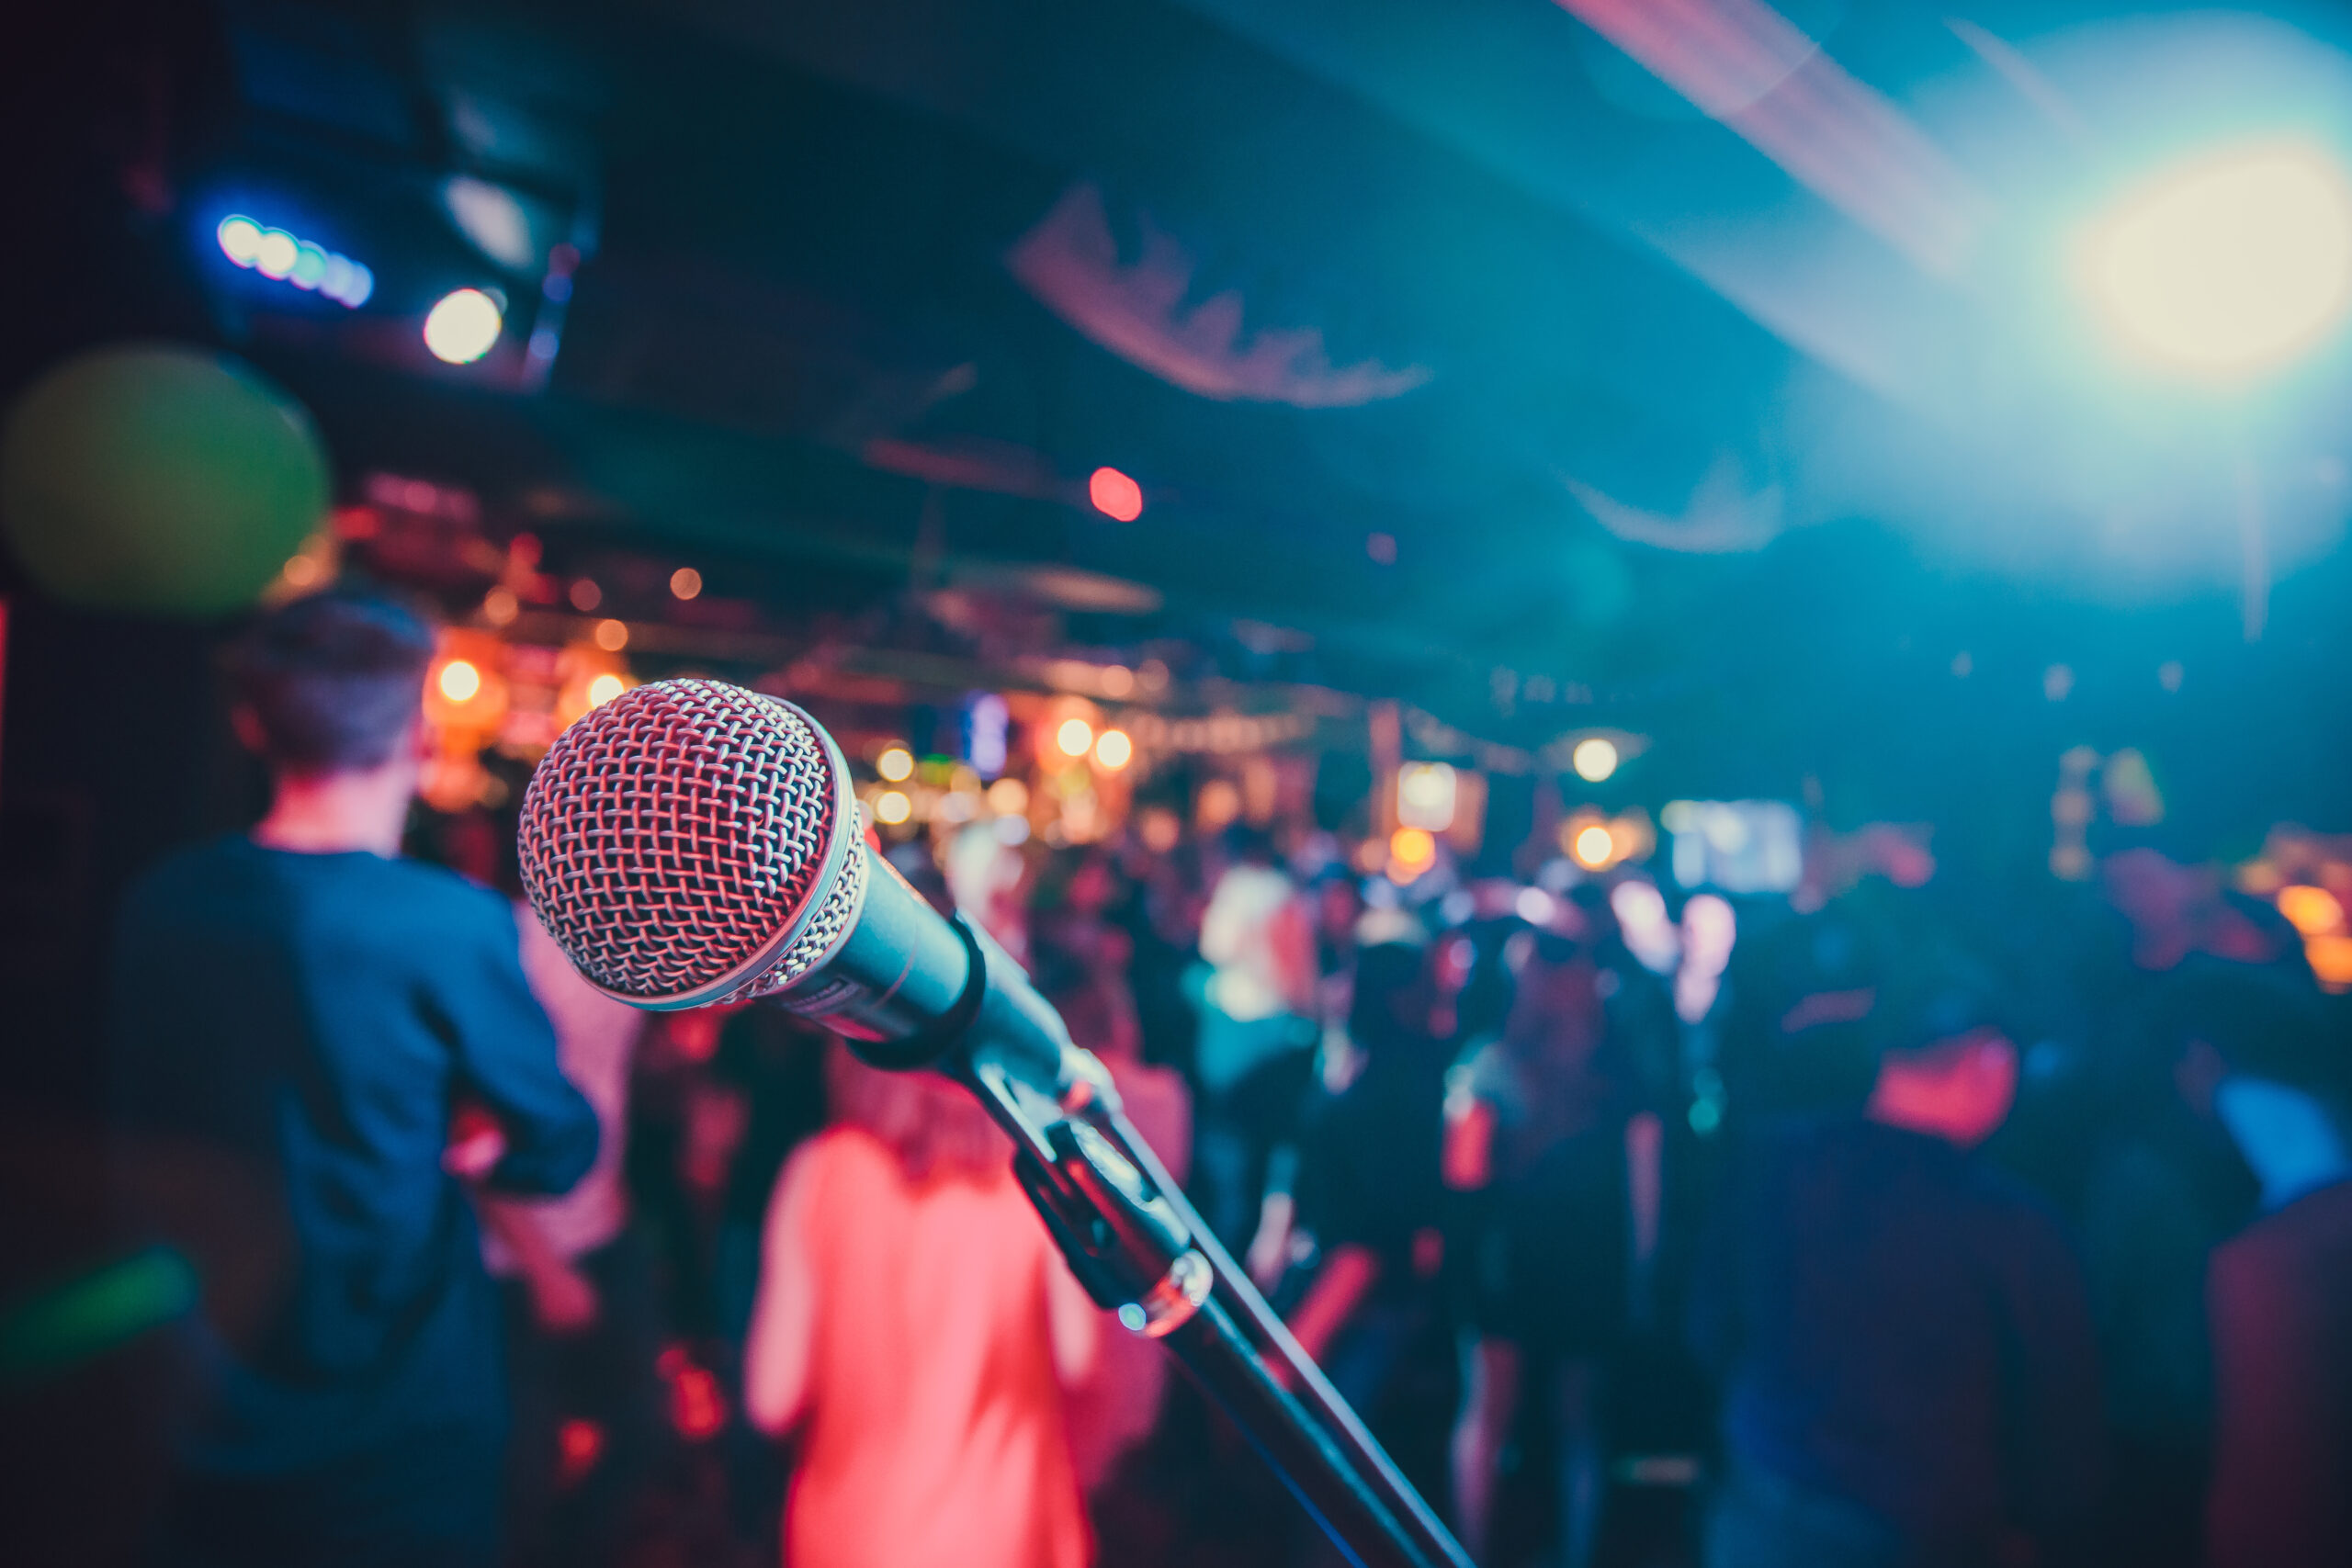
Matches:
[1557,0,1985,277]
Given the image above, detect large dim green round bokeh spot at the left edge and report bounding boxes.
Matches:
[0,344,329,616]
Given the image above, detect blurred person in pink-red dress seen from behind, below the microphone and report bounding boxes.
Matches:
[743,1051,1101,1568]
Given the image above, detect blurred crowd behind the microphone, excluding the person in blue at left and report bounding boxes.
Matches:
[106,592,2352,1568]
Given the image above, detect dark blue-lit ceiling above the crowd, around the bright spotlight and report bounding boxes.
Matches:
[7,0,2352,827]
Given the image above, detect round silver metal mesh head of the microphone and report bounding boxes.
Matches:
[520,680,865,1006]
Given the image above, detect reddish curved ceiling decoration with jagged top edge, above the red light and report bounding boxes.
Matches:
[1004,181,1430,409]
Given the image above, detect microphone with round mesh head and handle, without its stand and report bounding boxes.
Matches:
[520,680,1081,1102]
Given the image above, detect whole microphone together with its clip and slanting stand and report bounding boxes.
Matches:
[520,680,1470,1568]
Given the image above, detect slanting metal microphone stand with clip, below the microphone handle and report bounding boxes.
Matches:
[941,1029,1470,1568]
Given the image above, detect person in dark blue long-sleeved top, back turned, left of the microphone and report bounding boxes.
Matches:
[110,592,597,1568]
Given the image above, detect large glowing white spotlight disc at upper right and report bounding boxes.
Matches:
[2086,143,2352,378]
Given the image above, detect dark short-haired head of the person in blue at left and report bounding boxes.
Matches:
[228,590,433,776]
